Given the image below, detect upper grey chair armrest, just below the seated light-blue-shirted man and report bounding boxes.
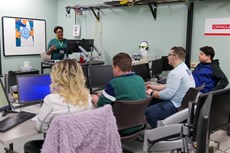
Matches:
[157,108,188,127]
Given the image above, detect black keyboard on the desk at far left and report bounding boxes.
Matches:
[0,111,36,132]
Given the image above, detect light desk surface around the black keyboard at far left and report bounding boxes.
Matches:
[0,104,40,145]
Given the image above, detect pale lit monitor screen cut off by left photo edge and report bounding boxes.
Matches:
[0,79,11,112]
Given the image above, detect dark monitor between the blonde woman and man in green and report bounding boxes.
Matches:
[89,65,113,90]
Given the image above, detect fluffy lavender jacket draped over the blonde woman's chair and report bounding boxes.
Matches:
[42,105,122,153]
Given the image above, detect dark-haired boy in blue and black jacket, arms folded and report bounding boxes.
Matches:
[192,46,228,93]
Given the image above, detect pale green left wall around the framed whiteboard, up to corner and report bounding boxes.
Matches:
[0,0,58,74]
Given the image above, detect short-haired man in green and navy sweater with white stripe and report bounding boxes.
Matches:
[91,53,146,136]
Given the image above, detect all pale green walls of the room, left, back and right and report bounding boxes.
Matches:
[0,0,230,83]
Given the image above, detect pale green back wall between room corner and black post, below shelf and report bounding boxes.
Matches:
[58,0,187,64]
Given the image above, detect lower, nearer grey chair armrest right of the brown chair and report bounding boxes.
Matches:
[143,124,183,151]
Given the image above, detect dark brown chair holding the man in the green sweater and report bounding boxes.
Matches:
[113,97,152,143]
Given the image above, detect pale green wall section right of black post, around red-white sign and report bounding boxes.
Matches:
[192,0,230,85]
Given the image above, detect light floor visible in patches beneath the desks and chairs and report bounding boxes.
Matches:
[0,130,230,153]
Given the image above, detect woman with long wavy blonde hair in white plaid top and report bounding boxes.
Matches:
[24,59,92,153]
